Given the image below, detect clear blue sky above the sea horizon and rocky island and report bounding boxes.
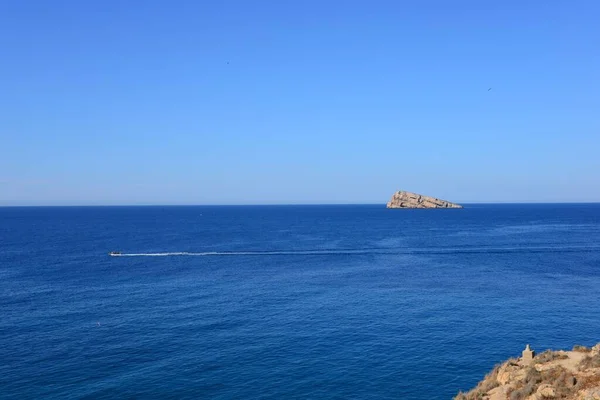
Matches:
[0,0,600,205]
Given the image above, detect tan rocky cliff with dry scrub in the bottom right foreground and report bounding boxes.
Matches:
[454,343,600,400]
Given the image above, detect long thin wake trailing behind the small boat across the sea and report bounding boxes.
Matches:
[112,245,600,257]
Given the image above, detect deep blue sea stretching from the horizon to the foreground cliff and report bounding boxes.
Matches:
[0,204,600,399]
